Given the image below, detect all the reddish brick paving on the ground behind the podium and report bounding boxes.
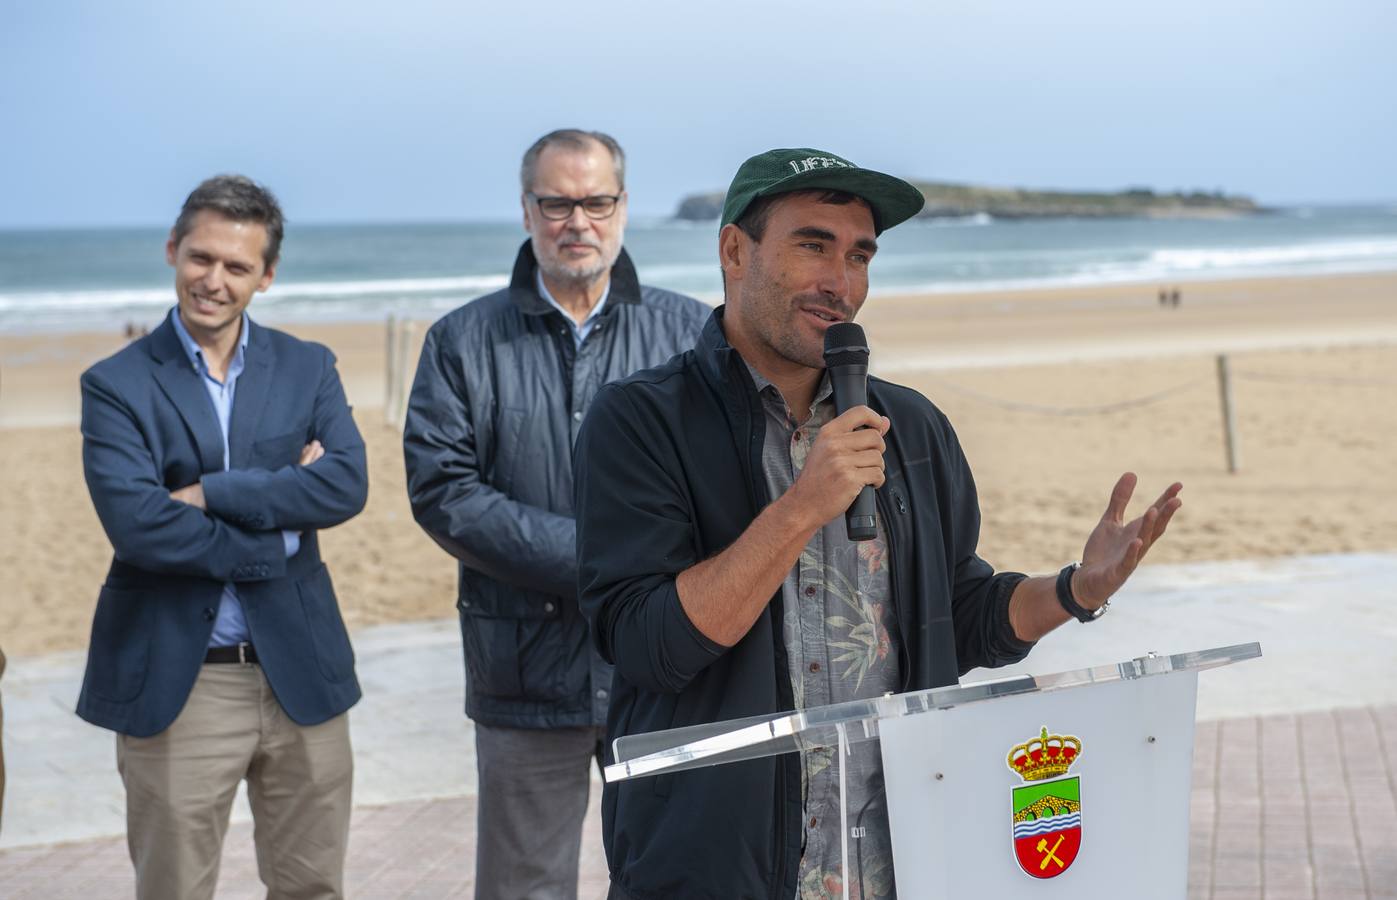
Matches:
[0,706,1397,900]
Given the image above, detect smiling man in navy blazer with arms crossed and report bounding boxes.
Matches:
[78,176,367,900]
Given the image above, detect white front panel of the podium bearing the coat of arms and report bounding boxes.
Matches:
[879,671,1197,900]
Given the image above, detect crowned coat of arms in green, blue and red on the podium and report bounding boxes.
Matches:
[1009,728,1081,878]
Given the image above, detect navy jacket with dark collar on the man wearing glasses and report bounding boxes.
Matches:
[402,242,710,728]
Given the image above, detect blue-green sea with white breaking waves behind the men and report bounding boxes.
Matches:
[0,205,1397,333]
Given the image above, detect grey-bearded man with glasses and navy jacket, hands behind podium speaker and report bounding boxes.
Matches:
[402,129,708,900]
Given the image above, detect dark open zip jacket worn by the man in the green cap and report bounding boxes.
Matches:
[574,309,1032,900]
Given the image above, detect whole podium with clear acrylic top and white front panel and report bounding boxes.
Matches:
[605,643,1261,900]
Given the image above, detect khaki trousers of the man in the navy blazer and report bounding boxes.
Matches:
[116,664,353,900]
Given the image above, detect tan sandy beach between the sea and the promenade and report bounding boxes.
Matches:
[0,274,1397,655]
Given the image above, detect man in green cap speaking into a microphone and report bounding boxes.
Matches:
[574,150,1180,900]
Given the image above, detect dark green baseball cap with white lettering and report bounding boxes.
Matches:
[718,147,926,233]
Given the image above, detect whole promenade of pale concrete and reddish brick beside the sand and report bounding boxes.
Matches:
[0,555,1397,900]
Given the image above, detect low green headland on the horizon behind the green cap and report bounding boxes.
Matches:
[675,182,1266,222]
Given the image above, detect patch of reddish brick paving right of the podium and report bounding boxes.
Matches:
[1189,706,1397,900]
